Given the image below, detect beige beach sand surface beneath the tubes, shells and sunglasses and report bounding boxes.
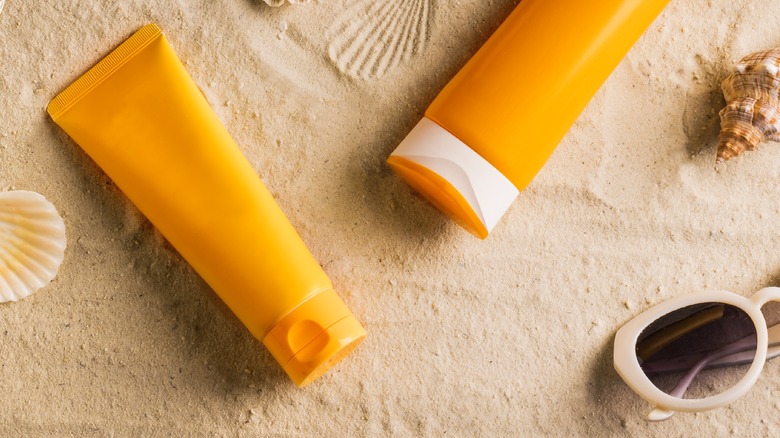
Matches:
[0,0,780,436]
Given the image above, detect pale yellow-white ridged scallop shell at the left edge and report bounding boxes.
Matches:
[0,190,66,302]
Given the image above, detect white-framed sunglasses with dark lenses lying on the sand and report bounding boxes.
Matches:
[614,287,780,421]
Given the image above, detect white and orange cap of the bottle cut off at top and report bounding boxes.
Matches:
[387,117,520,239]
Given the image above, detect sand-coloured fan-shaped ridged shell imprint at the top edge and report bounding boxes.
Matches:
[328,0,433,79]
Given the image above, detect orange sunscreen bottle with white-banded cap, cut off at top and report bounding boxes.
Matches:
[387,0,669,239]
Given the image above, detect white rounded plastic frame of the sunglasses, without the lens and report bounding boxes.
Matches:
[613,287,780,420]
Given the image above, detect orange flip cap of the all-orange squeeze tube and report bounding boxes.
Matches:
[263,290,366,388]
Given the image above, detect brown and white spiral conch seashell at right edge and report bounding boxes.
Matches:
[717,49,780,163]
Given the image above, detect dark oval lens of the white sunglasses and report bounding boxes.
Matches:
[636,303,756,399]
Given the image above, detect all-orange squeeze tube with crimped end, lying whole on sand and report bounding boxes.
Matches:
[48,24,365,386]
